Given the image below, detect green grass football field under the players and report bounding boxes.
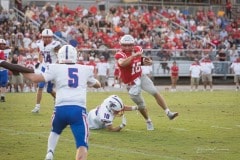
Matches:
[0,91,240,160]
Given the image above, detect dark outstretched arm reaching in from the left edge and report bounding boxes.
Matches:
[0,61,34,73]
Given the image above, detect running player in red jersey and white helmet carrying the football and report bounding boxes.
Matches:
[115,35,178,130]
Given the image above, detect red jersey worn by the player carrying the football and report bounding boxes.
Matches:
[115,46,142,84]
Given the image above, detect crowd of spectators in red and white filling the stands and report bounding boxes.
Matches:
[0,2,240,60]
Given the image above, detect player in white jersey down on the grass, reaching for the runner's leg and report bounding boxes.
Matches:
[88,95,138,132]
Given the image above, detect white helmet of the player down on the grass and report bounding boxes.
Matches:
[104,95,124,116]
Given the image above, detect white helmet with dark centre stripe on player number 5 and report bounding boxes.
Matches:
[57,45,77,63]
